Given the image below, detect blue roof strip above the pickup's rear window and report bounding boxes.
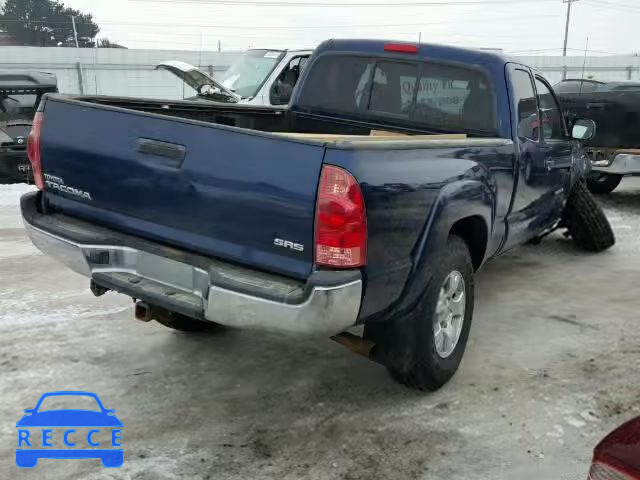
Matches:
[316,39,510,66]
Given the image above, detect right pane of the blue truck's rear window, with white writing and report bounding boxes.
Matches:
[414,62,496,132]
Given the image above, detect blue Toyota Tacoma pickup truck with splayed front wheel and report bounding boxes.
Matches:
[21,40,614,389]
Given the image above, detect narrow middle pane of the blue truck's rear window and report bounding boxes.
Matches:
[369,61,418,118]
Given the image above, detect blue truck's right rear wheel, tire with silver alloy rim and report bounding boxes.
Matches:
[383,236,474,390]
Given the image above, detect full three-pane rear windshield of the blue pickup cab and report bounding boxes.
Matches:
[299,55,496,133]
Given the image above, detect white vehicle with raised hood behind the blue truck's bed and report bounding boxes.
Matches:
[156,49,312,105]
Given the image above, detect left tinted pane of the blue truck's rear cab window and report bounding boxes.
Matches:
[300,55,373,113]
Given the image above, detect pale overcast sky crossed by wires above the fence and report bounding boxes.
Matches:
[63,0,640,55]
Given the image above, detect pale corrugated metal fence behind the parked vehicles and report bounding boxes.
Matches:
[0,47,640,99]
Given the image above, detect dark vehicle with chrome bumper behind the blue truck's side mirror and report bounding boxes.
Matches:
[554,80,640,194]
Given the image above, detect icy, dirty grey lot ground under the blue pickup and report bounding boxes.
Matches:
[0,179,640,480]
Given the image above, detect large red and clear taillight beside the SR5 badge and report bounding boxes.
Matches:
[315,165,367,268]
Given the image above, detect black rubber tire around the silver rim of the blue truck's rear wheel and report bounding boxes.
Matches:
[383,236,474,391]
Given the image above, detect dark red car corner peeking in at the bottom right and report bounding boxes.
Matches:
[589,418,640,480]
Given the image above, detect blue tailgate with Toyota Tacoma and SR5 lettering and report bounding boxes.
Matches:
[37,98,324,278]
